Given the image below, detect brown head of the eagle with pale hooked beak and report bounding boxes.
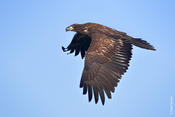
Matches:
[66,24,89,35]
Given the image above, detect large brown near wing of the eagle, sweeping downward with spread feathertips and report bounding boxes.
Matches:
[80,34,132,105]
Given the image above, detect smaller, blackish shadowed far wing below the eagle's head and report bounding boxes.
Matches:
[62,33,91,59]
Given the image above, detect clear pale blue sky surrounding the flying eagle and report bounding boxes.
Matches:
[0,0,175,117]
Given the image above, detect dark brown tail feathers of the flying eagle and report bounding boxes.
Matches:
[130,38,156,50]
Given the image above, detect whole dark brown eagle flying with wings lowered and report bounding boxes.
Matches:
[62,23,155,105]
